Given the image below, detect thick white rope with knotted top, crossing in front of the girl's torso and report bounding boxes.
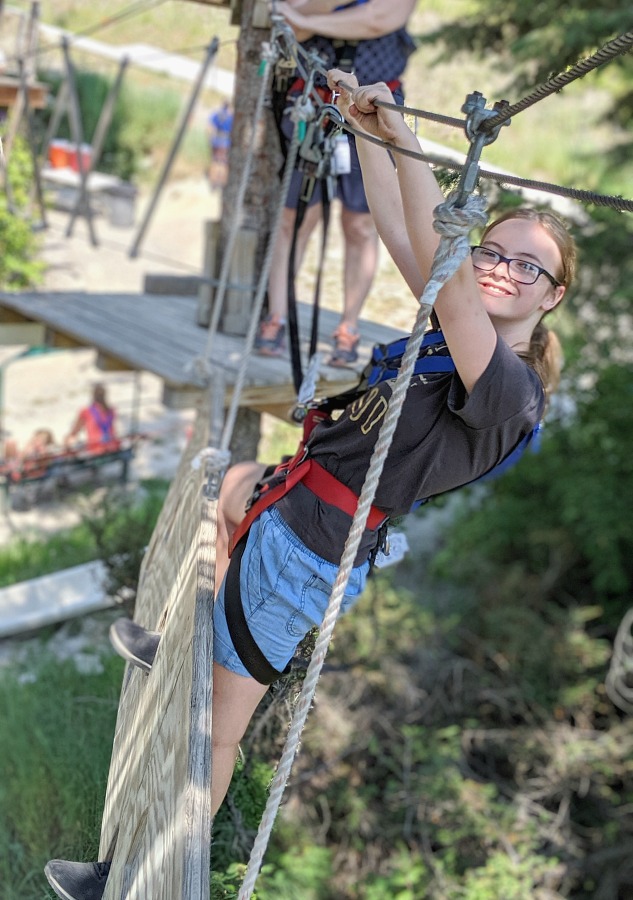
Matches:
[238,196,486,900]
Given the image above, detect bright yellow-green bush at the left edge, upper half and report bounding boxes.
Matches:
[0,137,43,290]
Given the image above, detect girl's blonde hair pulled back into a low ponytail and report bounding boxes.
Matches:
[481,206,576,400]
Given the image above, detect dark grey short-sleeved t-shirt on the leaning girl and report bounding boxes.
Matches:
[277,338,545,564]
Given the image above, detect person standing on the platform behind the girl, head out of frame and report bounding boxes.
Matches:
[255,0,415,367]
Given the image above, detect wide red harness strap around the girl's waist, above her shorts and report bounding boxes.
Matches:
[229,457,387,556]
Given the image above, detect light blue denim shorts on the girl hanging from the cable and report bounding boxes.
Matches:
[213,506,369,676]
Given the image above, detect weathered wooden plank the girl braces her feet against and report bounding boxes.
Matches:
[99,414,217,900]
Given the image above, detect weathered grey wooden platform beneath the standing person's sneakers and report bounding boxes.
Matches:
[0,292,403,418]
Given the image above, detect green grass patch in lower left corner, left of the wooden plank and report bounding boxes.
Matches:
[0,647,123,900]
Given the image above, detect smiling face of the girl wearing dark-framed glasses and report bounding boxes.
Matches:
[473,219,565,328]
